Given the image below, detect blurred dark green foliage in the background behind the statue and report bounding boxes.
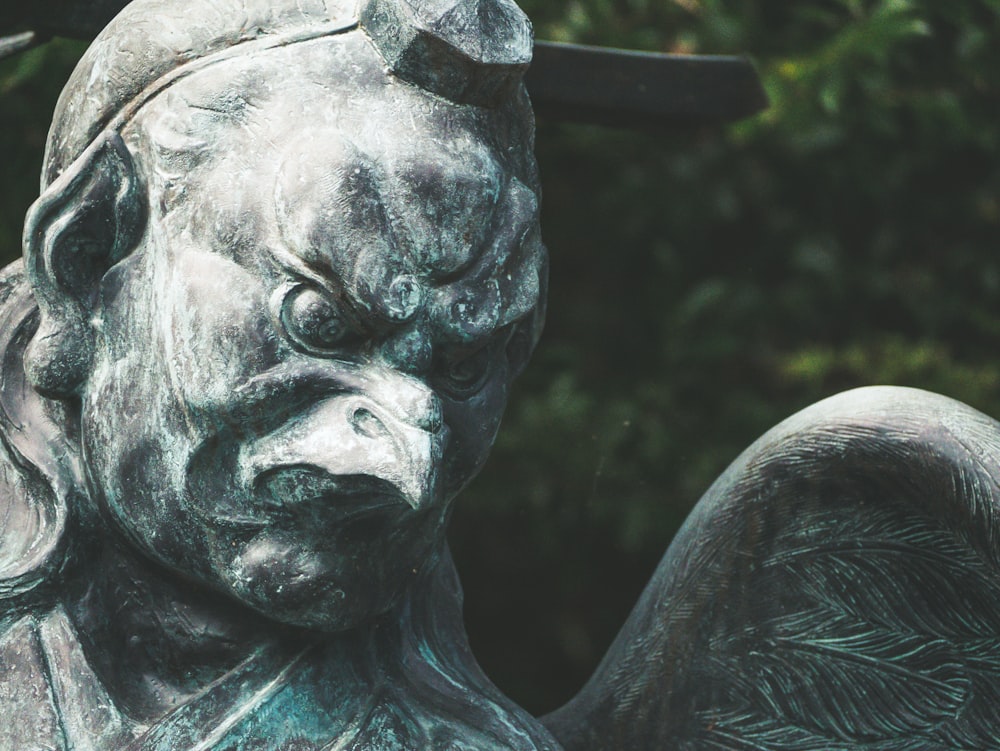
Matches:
[0,0,1000,713]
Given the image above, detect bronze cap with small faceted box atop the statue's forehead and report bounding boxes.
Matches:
[42,0,533,190]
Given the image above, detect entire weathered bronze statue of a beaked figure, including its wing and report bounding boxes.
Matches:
[0,0,1000,751]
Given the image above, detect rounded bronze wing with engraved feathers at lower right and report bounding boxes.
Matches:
[543,387,1000,751]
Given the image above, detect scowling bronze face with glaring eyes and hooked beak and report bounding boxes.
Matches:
[76,39,541,630]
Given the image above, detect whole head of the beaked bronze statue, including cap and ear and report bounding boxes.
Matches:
[0,0,545,630]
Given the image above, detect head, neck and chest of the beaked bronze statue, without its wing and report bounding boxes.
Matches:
[0,0,557,751]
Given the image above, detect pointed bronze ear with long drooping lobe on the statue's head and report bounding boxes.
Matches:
[24,131,146,397]
